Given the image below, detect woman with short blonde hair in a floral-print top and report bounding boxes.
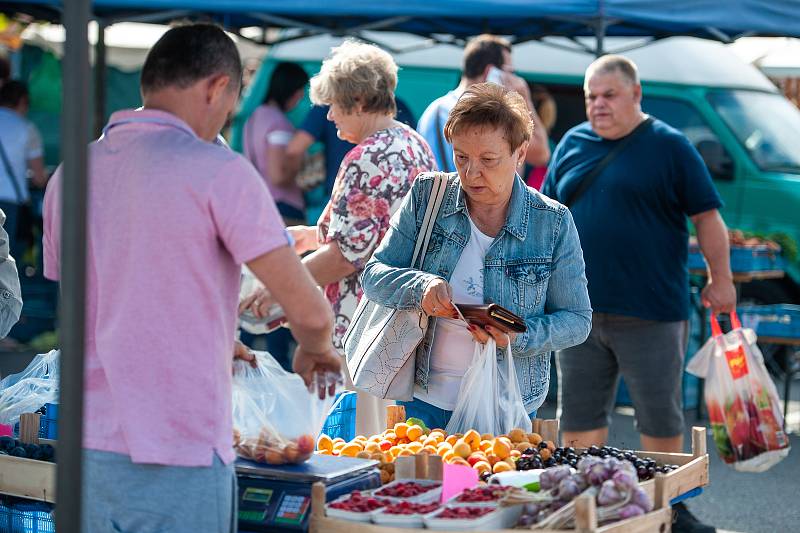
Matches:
[245,40,435,435]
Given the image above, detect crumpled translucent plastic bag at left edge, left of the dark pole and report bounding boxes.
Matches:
[0,350,61,426]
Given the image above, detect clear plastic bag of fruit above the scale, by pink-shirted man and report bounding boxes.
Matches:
[233,352,333,465]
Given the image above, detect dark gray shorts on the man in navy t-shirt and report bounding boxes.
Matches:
[556,313,689,438]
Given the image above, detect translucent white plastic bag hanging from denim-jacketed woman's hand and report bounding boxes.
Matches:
[447,337,531,435]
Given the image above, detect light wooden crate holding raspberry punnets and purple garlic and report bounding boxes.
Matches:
[309,455,672,533]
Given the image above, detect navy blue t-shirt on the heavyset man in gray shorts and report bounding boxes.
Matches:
[542,120,722,321]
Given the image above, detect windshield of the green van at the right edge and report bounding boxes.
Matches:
[708,90,800,174]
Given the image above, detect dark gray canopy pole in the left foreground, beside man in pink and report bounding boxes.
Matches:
[56,0,90,533]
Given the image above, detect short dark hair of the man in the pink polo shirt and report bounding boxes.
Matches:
[141,23,242,93]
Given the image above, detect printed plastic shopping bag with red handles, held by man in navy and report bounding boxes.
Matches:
[686,313,789,472]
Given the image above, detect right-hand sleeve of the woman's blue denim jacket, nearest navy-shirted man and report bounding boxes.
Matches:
[512,208,592,357]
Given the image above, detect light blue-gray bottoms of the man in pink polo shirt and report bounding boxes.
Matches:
[82,450,237,533]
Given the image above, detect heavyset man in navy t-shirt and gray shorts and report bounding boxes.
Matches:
[542,56,736,528]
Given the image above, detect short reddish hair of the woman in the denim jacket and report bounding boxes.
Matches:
[444,83,533,152]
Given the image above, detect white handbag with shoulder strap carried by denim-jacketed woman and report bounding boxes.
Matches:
[343,173,447,400]
